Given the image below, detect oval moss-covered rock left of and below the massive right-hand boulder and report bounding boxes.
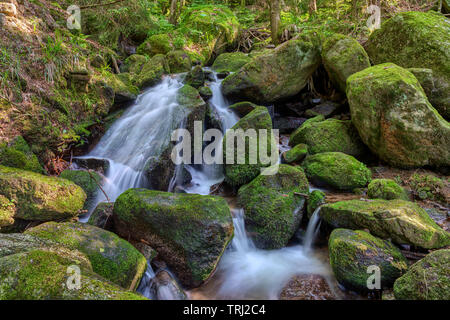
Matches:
[302,152,372,190]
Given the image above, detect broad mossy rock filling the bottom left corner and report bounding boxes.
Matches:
[0,249,146,300]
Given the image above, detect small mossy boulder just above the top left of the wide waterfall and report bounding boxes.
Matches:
[133,54,169,89]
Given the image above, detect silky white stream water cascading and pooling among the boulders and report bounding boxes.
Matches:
[76,69,338,300]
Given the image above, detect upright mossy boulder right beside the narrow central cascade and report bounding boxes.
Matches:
[223,107,278,186]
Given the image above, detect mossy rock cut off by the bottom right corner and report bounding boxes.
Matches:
[394,249,450,300]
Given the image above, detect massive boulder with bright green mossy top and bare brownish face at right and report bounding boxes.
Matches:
[347,63,450,167]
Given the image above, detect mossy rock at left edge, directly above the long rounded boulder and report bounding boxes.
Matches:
[0,136,44,173]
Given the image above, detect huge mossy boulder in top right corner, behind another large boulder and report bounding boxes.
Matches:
[366,11,450,119]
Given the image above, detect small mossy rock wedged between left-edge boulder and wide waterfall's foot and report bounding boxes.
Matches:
[59,169,103,209]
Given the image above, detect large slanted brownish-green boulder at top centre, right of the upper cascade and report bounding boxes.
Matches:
[222,40,320,103]
